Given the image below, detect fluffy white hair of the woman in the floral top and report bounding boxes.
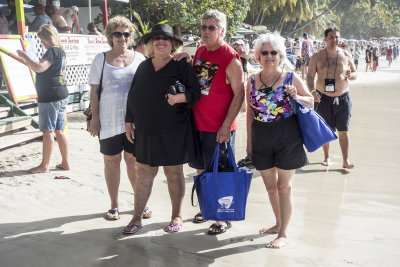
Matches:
[254,31,294,70]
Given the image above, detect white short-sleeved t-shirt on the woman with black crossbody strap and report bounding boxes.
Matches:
[89,52,145,139]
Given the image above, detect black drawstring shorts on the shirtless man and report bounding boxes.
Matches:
[315,92,352,131]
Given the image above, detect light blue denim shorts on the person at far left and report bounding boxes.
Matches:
[38,97,68,132]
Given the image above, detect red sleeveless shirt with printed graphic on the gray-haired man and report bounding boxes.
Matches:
[193,44,239,132]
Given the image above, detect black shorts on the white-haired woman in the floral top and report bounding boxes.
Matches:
[251,116,308,170]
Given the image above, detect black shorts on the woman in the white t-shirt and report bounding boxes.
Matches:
[100,133,135,156]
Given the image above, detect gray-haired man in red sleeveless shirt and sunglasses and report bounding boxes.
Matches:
[176,10,244,235]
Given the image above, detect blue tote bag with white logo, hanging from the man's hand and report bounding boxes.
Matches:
[192,143,253,221]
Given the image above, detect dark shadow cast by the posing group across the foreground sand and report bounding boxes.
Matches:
[0,212,265,266]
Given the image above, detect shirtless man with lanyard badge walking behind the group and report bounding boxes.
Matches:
[307,28,357,169]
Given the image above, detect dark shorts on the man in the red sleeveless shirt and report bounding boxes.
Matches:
[189,131,236,170]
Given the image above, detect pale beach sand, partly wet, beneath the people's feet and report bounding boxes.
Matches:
[0,58,400,267]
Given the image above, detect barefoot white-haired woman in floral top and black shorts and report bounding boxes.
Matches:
[246,32,313,248]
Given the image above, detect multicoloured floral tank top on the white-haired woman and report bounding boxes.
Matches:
[249,72,293,122]
